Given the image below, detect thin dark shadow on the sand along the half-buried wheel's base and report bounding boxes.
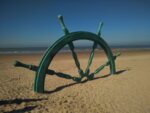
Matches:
[45,70,126,94]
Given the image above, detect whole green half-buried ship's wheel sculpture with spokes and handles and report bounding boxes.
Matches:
[14,15,120,93]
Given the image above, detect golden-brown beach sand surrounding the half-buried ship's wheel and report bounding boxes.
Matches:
[0,50,150,113]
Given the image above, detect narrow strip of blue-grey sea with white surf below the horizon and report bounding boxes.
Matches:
[0,45,150,55]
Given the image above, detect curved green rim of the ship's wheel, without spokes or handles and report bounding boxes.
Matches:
[34,31,116,93]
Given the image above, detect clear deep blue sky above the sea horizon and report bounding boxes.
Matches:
[0,0,150,48]
